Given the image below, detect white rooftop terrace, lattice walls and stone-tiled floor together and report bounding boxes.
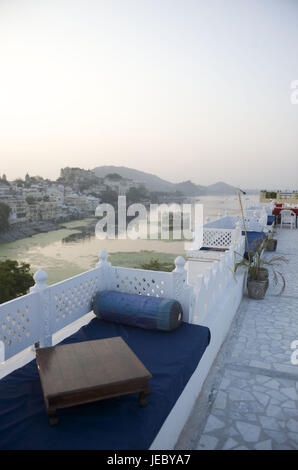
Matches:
[0,207,298,450]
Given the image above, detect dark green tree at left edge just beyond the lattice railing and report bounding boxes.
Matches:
[0,259,34,303]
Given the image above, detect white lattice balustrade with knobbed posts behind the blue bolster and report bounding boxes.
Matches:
[0,250,192,362]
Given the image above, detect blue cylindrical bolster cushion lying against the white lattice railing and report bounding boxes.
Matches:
[93,290,183,331]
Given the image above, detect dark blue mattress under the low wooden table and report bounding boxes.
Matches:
[0,319,210,450]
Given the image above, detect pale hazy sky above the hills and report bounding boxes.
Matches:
[0,0,298,189]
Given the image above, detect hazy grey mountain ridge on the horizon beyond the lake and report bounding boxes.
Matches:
[93,165,237,196]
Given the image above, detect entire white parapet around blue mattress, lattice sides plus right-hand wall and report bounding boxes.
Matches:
[0,237,244,449]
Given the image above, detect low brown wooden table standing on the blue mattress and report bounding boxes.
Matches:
[36,336,152,425]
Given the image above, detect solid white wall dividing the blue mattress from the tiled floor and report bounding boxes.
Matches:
[150,237,245,450]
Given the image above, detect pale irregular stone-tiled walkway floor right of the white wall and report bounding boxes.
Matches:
[176,228,298,450]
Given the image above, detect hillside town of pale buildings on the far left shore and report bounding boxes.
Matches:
[0,167,145,225]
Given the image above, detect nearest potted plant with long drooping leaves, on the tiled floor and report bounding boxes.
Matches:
[235,243,288,300]
